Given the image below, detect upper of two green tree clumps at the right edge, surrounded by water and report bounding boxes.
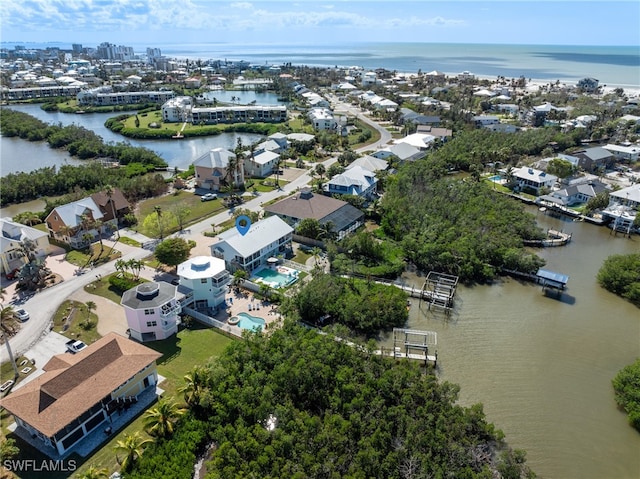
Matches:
[598,253,640,308]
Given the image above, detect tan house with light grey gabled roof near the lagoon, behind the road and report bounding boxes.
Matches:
[193,148,244,191]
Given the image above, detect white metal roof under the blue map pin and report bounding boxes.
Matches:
[212,215,293,258]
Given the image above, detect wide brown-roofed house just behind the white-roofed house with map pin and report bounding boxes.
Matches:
[264,188,364,239]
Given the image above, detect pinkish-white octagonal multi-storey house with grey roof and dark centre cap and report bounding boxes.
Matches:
[120,281,182,342]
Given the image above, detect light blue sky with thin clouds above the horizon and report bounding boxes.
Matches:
[0,0,640,46]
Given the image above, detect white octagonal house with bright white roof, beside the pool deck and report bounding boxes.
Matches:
[178,256,230,310]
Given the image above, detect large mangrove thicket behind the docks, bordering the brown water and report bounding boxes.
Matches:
[381,161,544,281]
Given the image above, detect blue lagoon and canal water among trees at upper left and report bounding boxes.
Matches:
[0,94,279,176]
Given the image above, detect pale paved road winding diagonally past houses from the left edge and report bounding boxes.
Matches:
[0,107,391,366]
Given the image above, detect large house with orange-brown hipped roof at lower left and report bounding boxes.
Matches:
[0,333,162,458]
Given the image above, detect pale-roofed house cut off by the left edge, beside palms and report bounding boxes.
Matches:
[0,218,49,274]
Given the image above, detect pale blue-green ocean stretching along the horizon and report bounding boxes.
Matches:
[1,42,640,89]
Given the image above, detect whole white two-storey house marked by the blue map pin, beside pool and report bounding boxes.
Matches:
[211,216,293,272]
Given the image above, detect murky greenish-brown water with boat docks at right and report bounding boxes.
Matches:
[383,207,640,479]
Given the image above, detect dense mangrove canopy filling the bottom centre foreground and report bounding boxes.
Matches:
[127,323,533,479]
